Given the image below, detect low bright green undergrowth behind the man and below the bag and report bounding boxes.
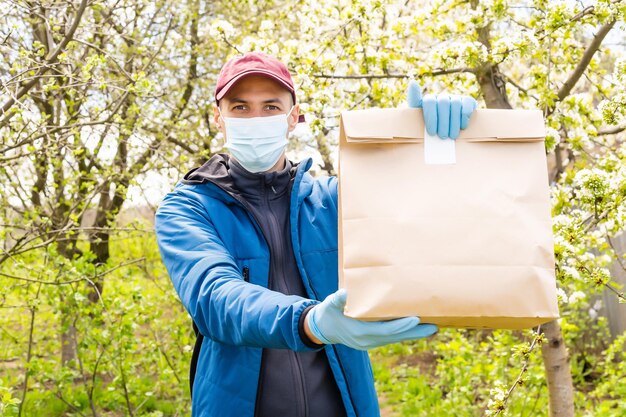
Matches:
[0,229,626,417]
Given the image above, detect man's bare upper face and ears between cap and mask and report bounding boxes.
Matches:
[214,75,299,131]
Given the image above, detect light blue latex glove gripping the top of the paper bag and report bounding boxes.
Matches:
[407,80,477,139]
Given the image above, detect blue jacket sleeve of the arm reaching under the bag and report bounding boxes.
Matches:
[155,188,316,351]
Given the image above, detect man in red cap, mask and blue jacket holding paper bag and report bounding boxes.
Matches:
[156,53,475,417]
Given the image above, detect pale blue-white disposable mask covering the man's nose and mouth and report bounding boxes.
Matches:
[218,106,293,172]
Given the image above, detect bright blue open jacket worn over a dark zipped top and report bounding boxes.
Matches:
[156,159,380,417]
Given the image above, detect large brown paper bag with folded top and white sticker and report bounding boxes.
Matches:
[339,109,558,329]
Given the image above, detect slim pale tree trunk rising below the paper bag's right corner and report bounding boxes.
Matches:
[541,320,574,417]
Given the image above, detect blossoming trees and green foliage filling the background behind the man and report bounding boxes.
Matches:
[0,0,626,416]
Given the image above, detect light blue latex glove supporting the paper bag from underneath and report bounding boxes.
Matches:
[306,289,438,350]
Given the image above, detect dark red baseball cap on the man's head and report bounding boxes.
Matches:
[215,52,304,122]
